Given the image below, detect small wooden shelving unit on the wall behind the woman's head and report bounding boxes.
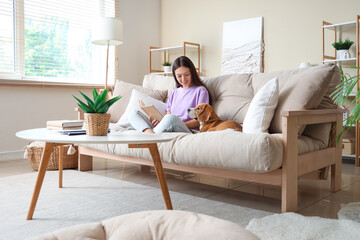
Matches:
[149,42,200,74]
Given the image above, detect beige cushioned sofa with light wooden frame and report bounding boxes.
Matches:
[79,64,342,212]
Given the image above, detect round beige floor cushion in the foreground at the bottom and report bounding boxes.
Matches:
[31,210,259,240]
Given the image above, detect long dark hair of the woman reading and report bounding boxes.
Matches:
[172,56,212,105]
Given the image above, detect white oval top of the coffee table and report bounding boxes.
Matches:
[16,128,174,144]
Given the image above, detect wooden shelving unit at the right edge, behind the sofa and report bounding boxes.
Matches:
[322,15,360,166]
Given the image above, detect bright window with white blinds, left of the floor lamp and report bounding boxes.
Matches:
[0,0,119,84]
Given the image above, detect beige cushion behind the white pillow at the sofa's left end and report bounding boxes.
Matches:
[108,81,167,123]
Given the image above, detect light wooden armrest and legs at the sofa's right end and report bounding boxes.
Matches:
[281,109,344,212]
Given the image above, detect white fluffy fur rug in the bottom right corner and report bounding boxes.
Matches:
[246,213,360,240]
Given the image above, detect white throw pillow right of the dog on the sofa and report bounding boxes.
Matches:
[243,77,279,133]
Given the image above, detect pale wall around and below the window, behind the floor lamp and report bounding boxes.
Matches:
[0,0,160,154]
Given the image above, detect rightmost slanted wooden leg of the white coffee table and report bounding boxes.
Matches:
[149,143,173,210]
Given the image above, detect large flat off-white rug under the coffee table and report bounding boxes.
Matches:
[0,170,271,240]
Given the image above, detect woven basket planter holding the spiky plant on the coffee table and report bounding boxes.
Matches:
[84,113,110,136]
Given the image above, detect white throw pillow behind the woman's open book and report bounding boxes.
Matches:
[116,89,166,127]
